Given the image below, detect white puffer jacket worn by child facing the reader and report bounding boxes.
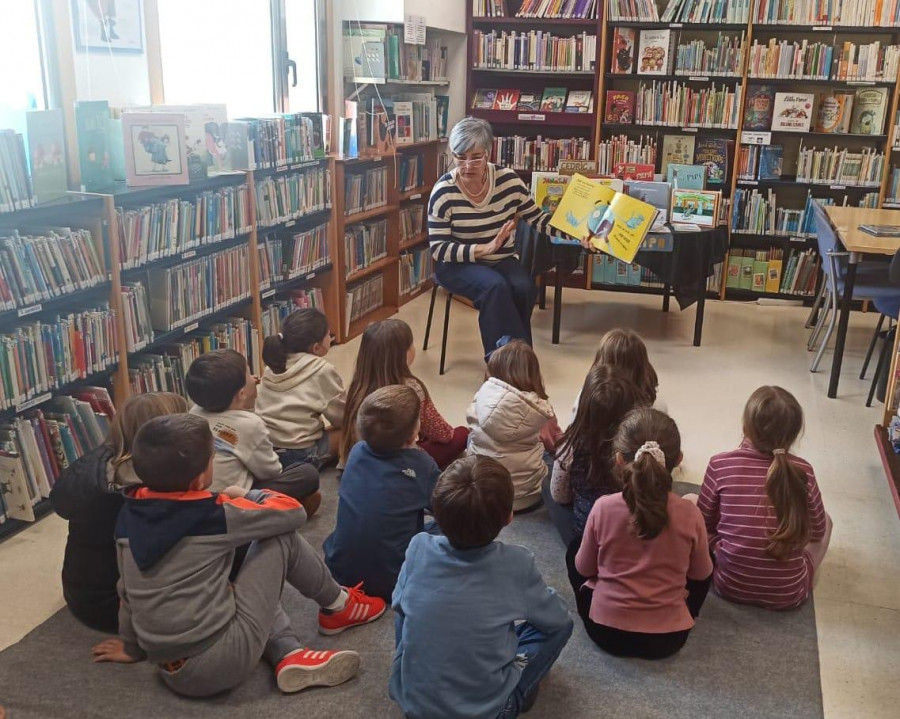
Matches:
[466,377,554,510]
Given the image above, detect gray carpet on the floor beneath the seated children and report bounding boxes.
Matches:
[0,473,823,719]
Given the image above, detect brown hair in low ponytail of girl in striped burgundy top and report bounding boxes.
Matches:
[743,386,811,559]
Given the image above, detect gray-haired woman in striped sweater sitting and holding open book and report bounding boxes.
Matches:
[428,117,551,355]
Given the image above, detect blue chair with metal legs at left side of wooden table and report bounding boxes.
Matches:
[807,202,900,372]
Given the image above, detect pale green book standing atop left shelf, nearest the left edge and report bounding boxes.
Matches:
[25,110,69,204]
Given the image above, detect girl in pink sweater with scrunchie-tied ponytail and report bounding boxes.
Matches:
[566,408,713,659]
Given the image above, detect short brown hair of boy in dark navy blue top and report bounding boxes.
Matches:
[356,384,422,454]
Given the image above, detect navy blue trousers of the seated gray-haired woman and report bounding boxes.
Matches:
[434,257,537,354]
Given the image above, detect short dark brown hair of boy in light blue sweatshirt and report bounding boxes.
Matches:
[431,455,515,549]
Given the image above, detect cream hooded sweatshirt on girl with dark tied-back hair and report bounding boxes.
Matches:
[256,352,347,449]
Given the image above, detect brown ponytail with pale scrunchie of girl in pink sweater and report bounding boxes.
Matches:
[613,408,681,539]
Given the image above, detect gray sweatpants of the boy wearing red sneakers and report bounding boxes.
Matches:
[161,532,341,697]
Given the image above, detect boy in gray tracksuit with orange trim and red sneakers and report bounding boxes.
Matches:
[94,414,385,696]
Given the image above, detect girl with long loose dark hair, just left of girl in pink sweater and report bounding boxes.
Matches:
[542,365,640,553]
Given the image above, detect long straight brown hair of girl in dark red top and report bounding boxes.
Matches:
[341,318,428,461]
